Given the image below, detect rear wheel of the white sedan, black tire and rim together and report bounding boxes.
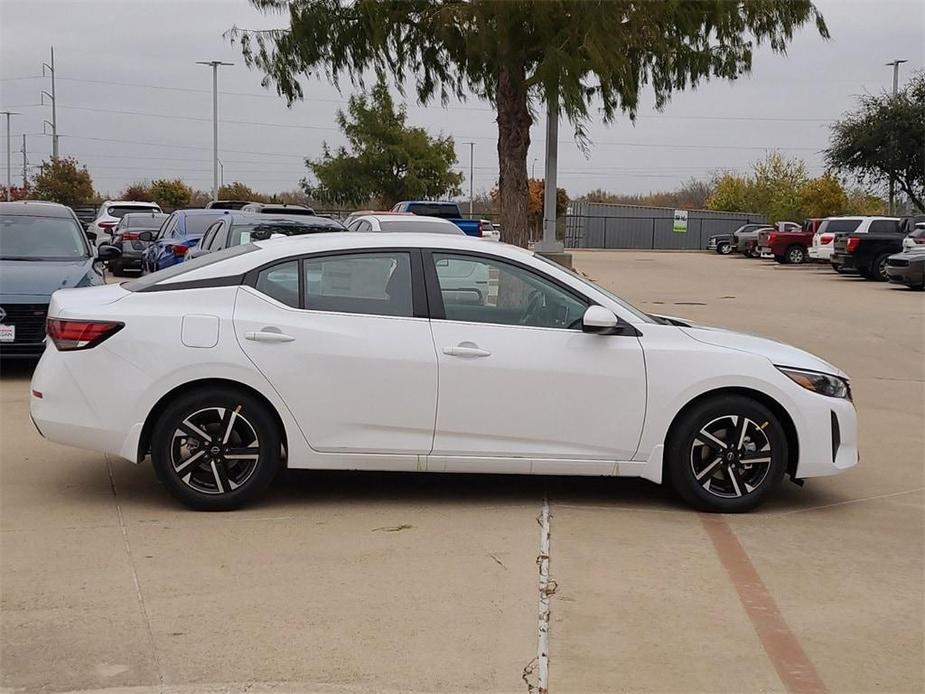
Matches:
[151,387,281,511]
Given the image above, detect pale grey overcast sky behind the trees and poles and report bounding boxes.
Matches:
[0,0,925,196]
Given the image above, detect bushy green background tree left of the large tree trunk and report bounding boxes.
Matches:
[302,82,462,209]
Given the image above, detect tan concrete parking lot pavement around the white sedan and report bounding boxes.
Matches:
[0,251,925,692]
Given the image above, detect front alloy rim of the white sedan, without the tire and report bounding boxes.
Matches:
[690,414,771,499]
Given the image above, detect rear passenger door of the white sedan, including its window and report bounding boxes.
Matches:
[234,251,437,454]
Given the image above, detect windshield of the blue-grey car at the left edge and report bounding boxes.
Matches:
[0,215,90,260]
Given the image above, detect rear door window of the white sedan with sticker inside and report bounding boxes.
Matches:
[303,252,414,317]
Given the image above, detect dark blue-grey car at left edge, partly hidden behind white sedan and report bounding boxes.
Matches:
[0,201,119,359]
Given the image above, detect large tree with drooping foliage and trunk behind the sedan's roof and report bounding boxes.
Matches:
[235,0,828,249]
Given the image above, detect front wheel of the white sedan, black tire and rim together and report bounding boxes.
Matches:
[665,395,788,513]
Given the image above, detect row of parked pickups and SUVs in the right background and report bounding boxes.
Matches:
[708,215,925,289]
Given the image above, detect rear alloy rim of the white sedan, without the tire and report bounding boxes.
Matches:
[170,405,260,494]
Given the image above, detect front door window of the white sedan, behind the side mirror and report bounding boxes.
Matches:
[433,253,589,330]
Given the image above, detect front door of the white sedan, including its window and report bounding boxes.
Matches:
[425,251,646,470]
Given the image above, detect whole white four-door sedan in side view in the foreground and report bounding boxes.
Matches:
[31,233,858,512]
